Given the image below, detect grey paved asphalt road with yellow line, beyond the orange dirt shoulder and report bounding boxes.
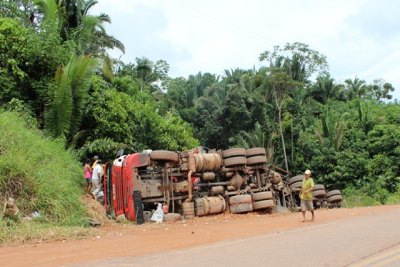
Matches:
[71,209,400,267]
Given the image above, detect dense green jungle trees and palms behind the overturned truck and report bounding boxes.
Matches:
[0,0,400,207]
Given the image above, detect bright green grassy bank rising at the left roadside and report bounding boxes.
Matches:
[0,110,87,242]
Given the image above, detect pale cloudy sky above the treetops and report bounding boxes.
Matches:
[92,0,400,100]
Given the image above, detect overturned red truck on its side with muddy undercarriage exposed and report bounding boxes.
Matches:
[103,148,340,223]
